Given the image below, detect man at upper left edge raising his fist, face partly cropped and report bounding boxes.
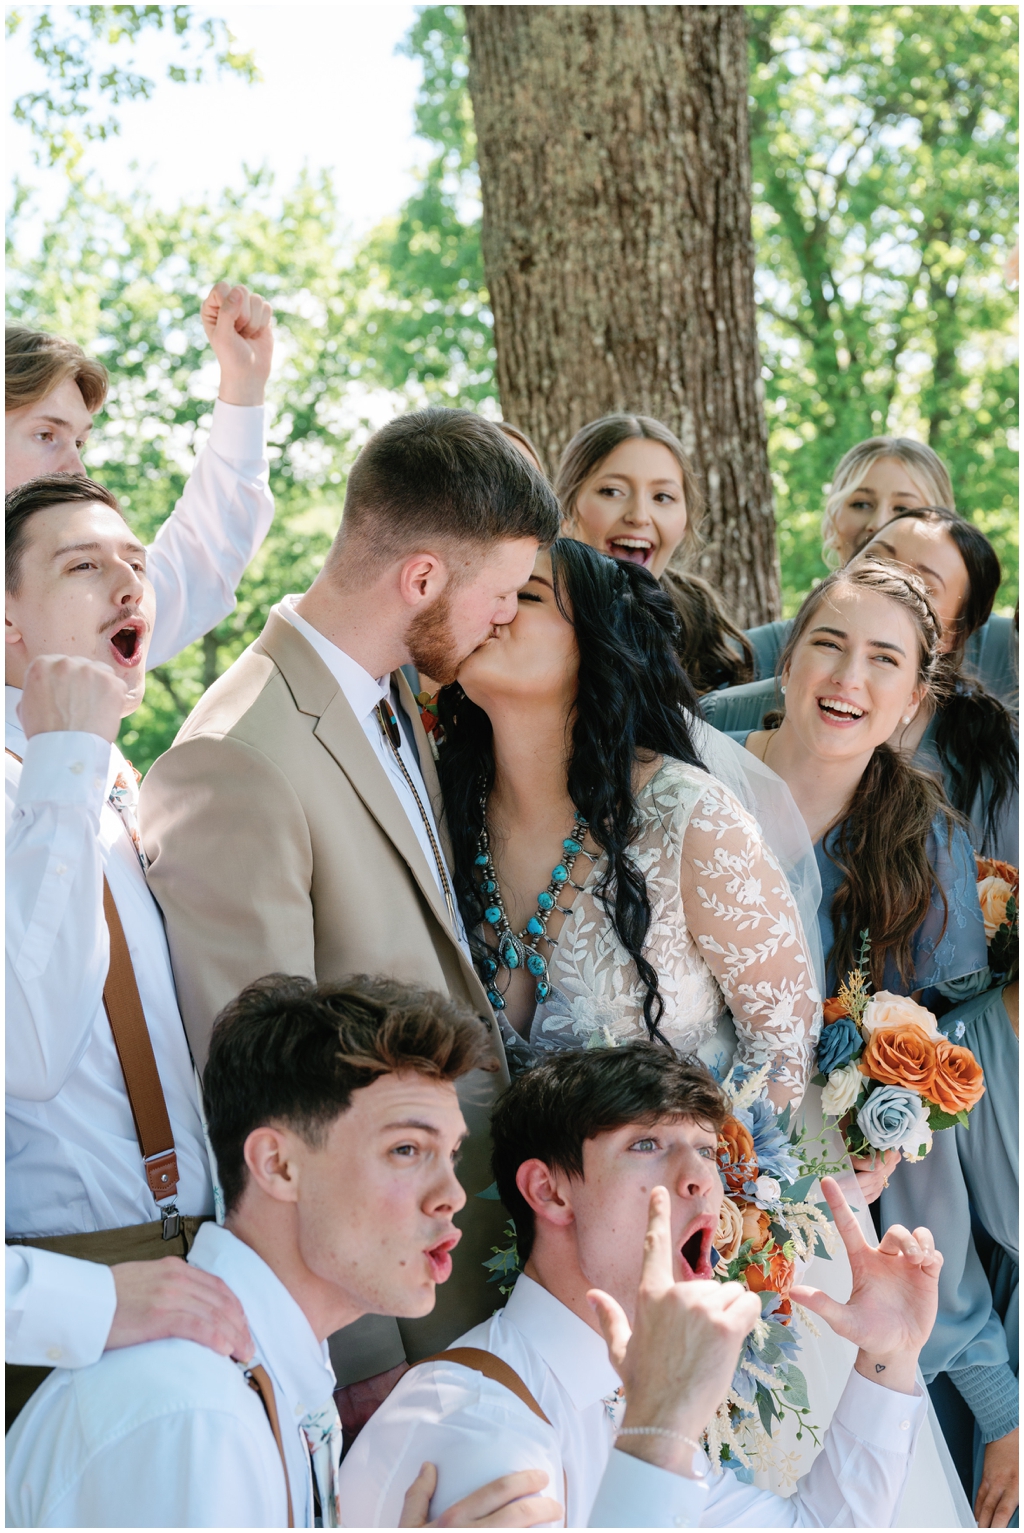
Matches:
[5,282,274,670]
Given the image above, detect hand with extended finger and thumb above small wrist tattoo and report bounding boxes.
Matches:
[793,1176,943,1393]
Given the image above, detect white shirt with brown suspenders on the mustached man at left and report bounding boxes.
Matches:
[5,687,213,1236]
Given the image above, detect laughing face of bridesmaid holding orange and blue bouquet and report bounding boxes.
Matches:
[782,584,923,760]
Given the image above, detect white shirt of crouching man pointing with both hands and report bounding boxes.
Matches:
[340,1277,926,1528]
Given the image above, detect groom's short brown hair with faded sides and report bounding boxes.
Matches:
[328,408,561,567]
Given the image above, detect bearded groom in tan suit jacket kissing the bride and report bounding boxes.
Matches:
[139,409,560,1398]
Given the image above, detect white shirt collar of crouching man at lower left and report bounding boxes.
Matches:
[189,1223,337,1420]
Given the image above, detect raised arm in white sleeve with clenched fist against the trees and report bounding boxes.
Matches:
[147,282,274,670]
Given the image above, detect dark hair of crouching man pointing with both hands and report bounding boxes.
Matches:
[491,1042,728,1263]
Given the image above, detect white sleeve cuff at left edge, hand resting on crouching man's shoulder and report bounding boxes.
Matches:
[5,1246,118,1367]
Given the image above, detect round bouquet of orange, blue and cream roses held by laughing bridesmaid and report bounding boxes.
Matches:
[816,932,984,1160]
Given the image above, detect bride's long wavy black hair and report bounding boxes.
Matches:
[438,538,704,1041]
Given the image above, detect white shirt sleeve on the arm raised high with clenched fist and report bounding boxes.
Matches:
[146,399,274,670]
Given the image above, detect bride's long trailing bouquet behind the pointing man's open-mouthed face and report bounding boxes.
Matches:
[707,1065,840,1481]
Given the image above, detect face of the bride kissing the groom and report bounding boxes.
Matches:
[458,553,579,713]
